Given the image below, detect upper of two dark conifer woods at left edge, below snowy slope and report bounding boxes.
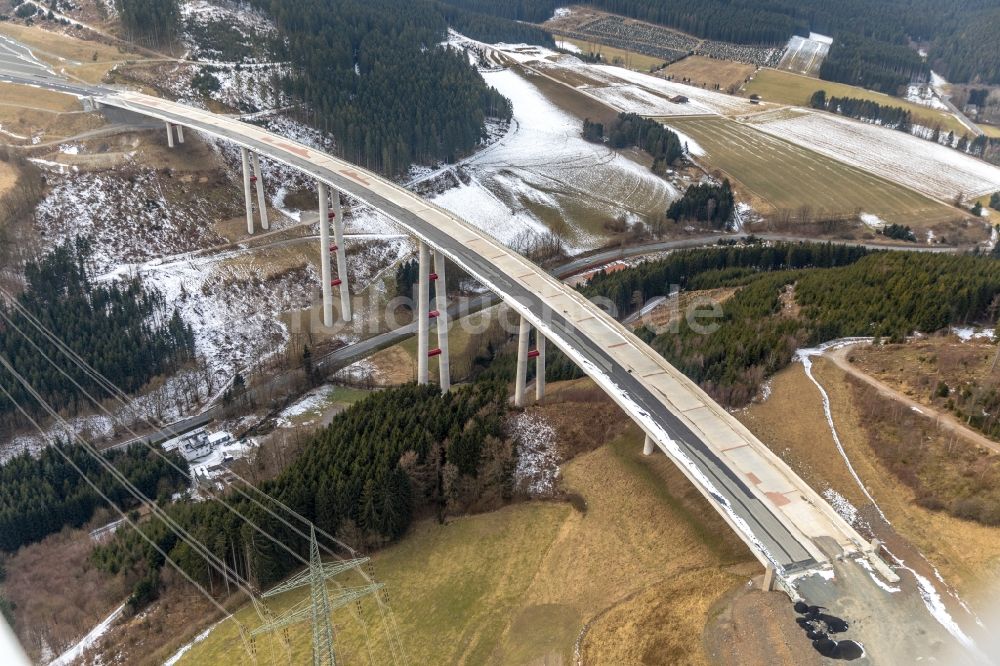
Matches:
[0,237,194,426]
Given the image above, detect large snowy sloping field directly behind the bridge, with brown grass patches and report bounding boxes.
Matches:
[433,70,677,252]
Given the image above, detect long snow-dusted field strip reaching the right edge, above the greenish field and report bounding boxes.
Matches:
[754,111,1000,201]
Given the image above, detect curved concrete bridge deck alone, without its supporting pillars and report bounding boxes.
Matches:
[94,91,871,578]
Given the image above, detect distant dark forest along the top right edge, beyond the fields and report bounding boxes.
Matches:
[460,0,1000,87]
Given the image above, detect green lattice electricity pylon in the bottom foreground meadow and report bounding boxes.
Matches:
[250,527,383,666]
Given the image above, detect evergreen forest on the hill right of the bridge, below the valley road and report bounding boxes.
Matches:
[583,245,1000,406]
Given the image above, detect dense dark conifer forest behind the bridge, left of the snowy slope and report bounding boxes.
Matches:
[242,0,524,175]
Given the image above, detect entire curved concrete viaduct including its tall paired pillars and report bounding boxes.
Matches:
[0,62,972,663]
